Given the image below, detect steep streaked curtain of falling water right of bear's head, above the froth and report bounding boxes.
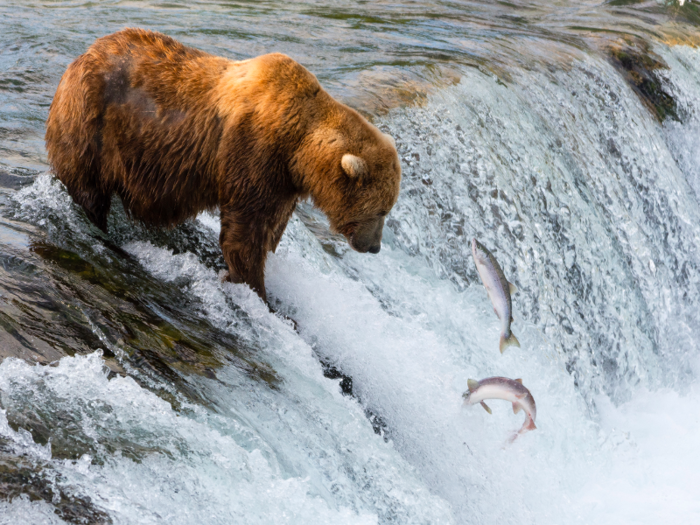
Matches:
[378,46,700,406]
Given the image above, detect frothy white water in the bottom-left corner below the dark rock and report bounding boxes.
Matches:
[0,352,440,524]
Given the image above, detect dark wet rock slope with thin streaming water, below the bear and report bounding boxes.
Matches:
[0,229,278,403]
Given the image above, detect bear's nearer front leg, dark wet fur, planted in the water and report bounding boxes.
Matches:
[219,208,267,302]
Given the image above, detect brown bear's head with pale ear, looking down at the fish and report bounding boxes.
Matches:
[295,104,401,253]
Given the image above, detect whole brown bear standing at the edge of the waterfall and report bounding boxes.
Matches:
[46,29,401,299]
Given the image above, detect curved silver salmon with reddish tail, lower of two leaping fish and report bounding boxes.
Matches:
[462,377,537,438]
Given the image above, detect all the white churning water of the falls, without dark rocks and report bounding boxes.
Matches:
[0,44,700,524]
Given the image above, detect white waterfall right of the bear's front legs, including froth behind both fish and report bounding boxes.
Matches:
[270,42,700,523]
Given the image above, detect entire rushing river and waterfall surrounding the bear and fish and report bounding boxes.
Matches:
[0,0,700,525]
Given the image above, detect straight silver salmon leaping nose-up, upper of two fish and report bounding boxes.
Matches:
[472,239,520,353]
